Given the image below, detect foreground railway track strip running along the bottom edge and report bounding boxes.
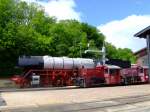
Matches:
[0,94,150,112]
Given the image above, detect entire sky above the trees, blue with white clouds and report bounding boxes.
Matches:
[22,0,150,52]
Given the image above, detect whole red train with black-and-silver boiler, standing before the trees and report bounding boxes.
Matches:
[11,56,149,88]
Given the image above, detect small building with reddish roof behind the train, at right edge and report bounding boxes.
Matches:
[134,47,148,66]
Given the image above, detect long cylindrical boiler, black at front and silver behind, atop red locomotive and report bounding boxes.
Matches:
[18,56,95,69]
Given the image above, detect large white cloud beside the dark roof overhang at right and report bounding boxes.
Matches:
[98,15,150,51]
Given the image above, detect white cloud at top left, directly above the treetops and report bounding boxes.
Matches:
[22,0,81,20]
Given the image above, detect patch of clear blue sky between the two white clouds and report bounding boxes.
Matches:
[75,0,150,26]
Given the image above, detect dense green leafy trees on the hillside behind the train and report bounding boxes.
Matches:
[0,0,135,75]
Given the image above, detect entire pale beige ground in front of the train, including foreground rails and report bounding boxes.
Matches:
[0,84,150,112]
